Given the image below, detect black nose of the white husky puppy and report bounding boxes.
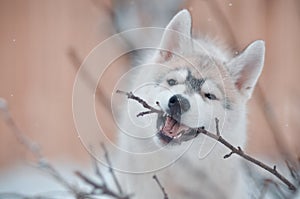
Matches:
[168,95,191,114]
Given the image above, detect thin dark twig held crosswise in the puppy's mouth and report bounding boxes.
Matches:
[119,91,297,191]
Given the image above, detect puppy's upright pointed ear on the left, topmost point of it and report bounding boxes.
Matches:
[158,10,192,61]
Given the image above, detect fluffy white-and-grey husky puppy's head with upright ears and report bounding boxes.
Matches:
[151,10,264,143]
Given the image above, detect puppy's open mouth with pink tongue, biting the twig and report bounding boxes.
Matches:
[157,114,199,144]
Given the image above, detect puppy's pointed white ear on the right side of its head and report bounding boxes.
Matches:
[227,40,265,99]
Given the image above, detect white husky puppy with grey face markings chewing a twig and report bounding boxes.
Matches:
[118,10,265,199]
